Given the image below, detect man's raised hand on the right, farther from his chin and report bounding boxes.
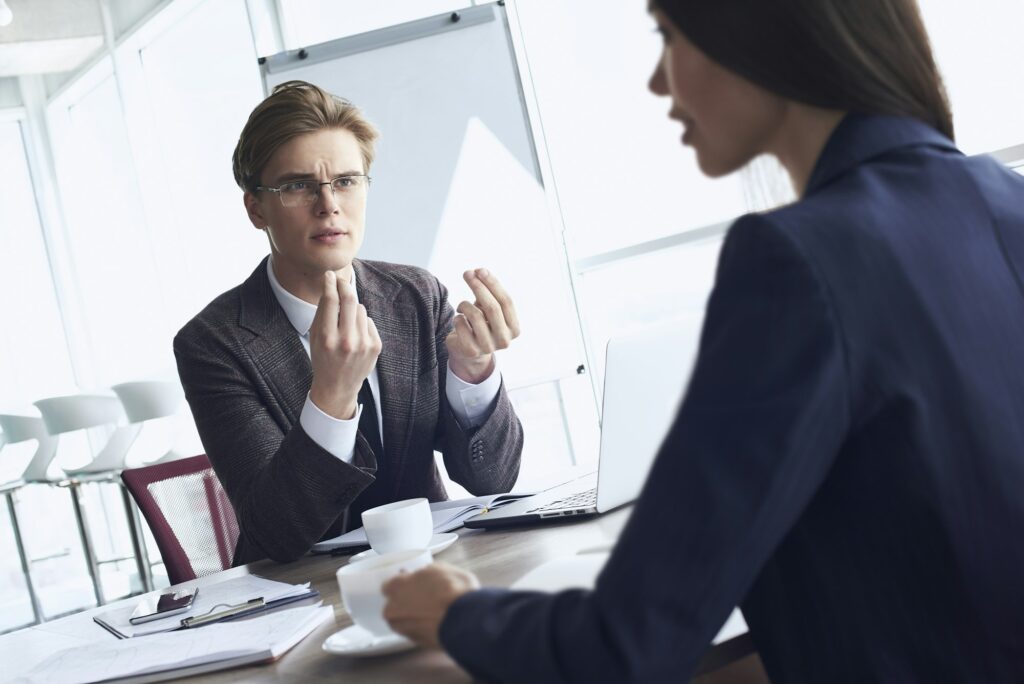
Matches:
[444,268,519,385]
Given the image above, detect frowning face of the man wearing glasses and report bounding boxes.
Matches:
[245,128,367,282]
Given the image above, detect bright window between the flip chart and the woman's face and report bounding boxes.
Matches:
[515,0,745,259]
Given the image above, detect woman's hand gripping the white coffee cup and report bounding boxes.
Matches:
[382,563,480,648]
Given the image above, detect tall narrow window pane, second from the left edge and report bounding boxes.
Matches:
[48,66,168,387]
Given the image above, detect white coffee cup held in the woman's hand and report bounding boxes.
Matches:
[337,549,433,637]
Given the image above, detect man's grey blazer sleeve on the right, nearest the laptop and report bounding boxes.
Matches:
[434,279,523,496]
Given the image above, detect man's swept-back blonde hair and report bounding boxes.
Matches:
[231,81,379,193]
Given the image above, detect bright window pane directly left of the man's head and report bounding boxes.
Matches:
[118,0,268,335]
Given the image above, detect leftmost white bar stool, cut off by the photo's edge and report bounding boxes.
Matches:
[0,414,57,623]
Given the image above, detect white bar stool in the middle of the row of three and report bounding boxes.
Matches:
[35,394,150,605]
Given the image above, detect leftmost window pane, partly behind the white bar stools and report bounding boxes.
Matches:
[0,113,91,631]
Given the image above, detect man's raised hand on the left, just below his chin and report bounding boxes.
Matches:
[309,270,381,420]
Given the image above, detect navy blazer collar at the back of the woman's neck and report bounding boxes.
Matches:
[806,113,956,195]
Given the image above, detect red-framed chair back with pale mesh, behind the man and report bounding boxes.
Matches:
[121,455,239,585]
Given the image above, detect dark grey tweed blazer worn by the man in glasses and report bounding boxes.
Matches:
[174,260,523,565]
